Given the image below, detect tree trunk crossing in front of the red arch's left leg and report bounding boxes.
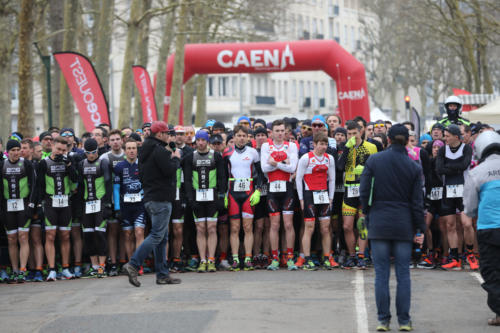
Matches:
[168,0,188,124]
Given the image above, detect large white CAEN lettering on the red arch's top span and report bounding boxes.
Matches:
[217,44,295,70]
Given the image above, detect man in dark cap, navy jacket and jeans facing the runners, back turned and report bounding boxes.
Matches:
[360,124,425,332]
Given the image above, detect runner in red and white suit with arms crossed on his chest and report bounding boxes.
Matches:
[260,120,298,270]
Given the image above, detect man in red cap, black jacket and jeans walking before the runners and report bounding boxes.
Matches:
[123,121,181,287]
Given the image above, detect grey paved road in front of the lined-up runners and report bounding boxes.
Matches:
[0,270,499,333]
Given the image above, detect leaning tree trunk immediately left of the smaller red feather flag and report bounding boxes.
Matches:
[118,0,142,128]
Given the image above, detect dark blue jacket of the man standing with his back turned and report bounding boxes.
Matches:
[360,144,425,241]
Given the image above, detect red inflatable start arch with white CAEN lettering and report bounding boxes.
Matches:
[164,40,370,124]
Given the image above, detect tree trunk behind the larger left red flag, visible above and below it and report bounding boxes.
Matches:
[59,0,78,127]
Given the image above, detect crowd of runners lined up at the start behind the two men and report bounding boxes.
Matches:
[0,96,494,283]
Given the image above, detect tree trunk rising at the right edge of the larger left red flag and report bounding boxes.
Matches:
[94,0,115,98]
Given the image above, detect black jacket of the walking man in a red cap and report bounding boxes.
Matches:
[139,136,180,202]
